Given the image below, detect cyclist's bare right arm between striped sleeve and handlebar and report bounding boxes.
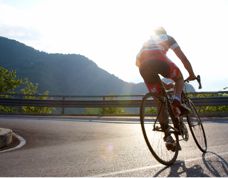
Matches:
[173,47,196,80]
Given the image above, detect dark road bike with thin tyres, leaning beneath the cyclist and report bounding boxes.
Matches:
[140,75,207,165]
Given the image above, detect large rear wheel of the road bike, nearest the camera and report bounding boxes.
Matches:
[140,93,179,165]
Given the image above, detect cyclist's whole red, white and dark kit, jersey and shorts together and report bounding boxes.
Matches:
[137,34,181,92]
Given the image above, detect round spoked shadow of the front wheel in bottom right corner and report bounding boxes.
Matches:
[203,151,228,177]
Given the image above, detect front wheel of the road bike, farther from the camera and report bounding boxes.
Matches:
[187,100,207,153]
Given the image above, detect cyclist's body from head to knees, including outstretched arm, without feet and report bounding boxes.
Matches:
[136,27,196,97]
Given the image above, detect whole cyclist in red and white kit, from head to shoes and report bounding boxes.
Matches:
[136,27,196,149]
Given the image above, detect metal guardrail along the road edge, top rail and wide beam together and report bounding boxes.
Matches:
[0,92,228,115]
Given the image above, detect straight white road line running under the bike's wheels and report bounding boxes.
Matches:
[92,151,228,177]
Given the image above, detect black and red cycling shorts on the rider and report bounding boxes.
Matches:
[139,51,182,93]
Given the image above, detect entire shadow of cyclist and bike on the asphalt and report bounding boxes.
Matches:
[154,152,228,177]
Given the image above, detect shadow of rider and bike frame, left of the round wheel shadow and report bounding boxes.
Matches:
[154,161,209,177]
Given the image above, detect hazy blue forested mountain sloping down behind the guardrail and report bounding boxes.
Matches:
[0,37,194,95]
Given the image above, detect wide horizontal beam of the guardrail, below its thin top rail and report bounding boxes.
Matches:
[0,97,228,108]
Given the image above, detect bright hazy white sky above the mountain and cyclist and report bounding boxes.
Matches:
[0,0,228,91]
